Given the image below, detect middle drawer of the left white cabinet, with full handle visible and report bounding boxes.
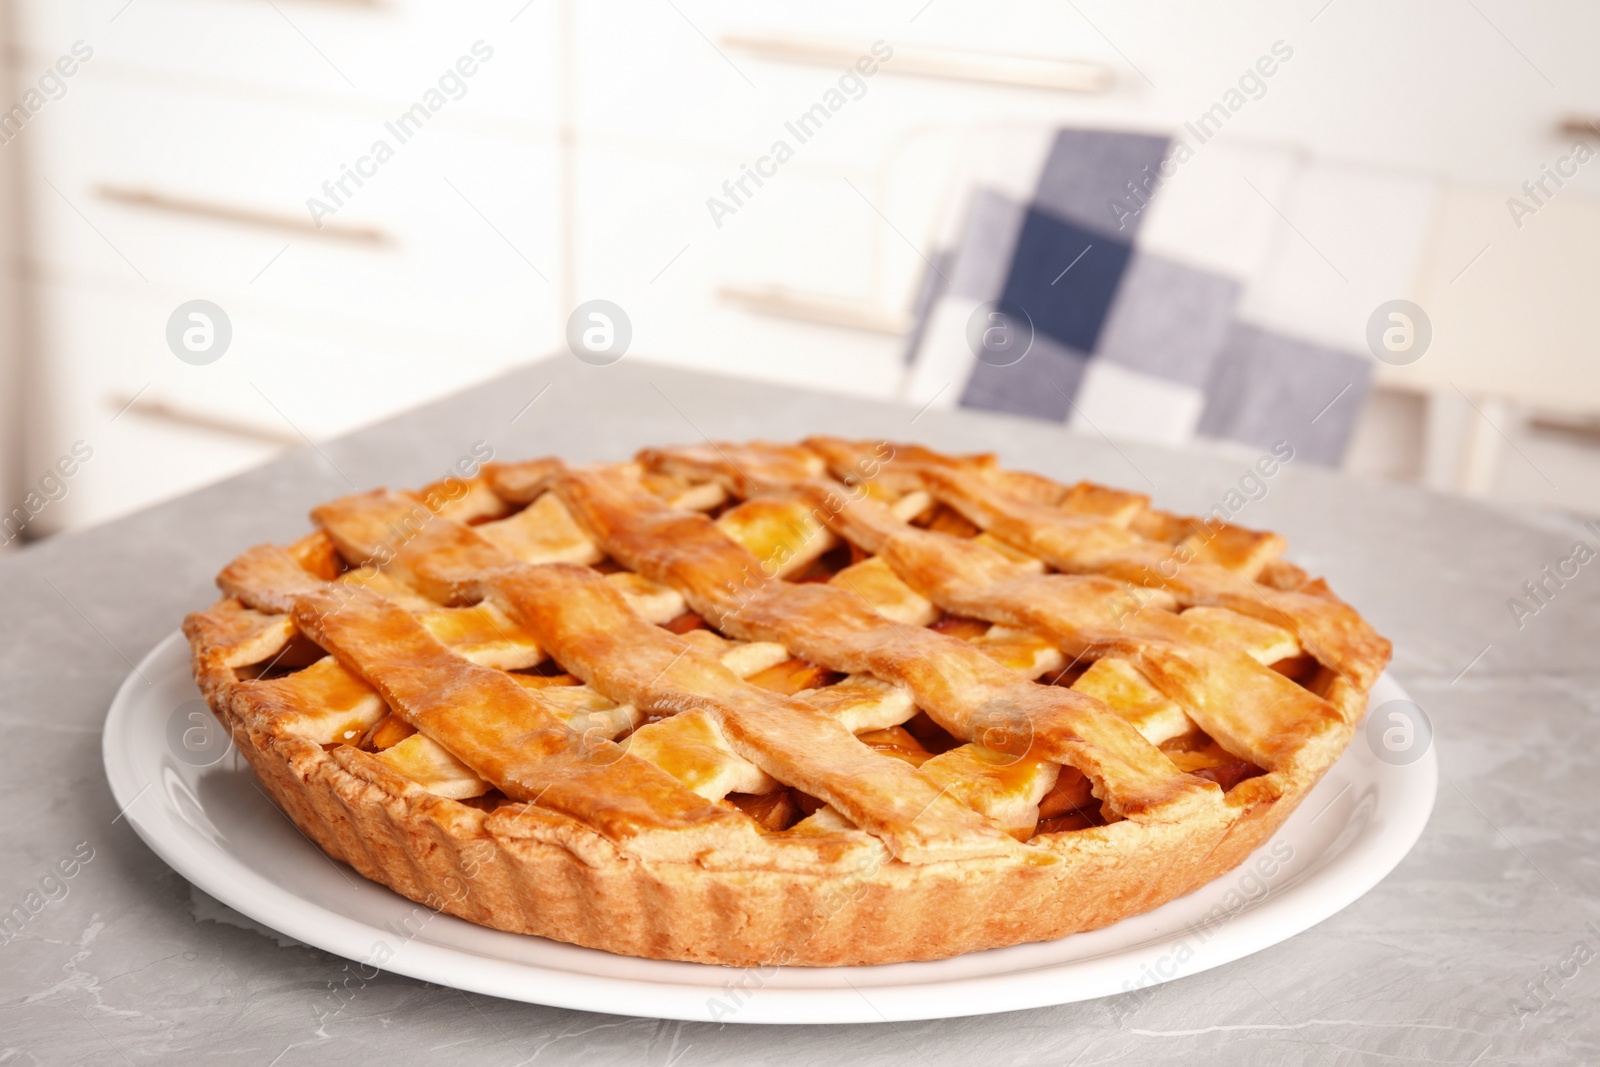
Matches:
[26,80,558,360]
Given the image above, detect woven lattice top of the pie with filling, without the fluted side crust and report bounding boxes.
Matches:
[190,438,1387,862]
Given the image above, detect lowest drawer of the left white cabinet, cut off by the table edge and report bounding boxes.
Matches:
[26,273,531,530]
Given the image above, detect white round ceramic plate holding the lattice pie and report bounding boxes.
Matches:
[102,633,1438,1022]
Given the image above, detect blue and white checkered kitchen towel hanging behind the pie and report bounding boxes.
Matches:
[907,130,1430,466]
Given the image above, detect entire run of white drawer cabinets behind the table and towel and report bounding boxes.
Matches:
[18,0,1600,525]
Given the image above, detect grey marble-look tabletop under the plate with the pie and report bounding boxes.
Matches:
[0,357,1600,1067]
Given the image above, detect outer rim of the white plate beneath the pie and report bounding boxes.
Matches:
[101,630,1438,1024]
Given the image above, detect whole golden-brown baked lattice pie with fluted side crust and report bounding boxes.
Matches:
[184,437,1390,966]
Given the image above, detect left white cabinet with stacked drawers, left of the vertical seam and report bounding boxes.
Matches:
[6,0,565,531]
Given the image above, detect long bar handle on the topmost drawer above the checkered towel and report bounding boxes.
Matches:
[722,34,1112,93]
